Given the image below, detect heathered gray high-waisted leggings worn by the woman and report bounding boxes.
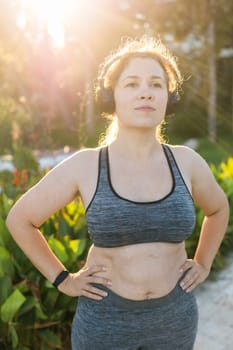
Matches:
[71,283,198,350]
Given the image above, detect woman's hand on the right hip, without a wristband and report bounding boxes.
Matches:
[180,259,210,292]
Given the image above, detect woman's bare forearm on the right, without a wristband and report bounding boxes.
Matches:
[194,203,229,270]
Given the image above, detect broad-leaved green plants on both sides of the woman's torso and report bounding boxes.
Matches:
[0,158,233,350]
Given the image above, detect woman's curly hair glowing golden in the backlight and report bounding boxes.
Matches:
[96,36,183,146]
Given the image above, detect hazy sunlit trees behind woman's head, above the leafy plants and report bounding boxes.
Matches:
[0,0,233,162]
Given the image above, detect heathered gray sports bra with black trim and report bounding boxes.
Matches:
[86,144,196,248]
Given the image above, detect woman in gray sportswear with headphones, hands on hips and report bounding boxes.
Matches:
[7,38,228,350]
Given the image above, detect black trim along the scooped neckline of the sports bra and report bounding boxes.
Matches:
[106,144,176,205]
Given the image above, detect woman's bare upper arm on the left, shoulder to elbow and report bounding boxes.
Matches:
[8,151,96,227]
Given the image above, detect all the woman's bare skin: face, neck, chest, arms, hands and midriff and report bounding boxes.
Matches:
[7,58,229,300]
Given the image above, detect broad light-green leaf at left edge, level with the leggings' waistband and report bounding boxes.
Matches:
[1,289,26,323]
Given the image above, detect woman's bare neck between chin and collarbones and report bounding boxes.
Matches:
[111,128,160,158]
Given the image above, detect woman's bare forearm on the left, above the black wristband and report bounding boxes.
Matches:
[7,220,64,282]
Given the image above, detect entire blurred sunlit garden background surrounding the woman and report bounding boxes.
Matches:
[0,0,233,350]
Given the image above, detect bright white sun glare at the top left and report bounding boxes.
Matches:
[19,0,77,47]
